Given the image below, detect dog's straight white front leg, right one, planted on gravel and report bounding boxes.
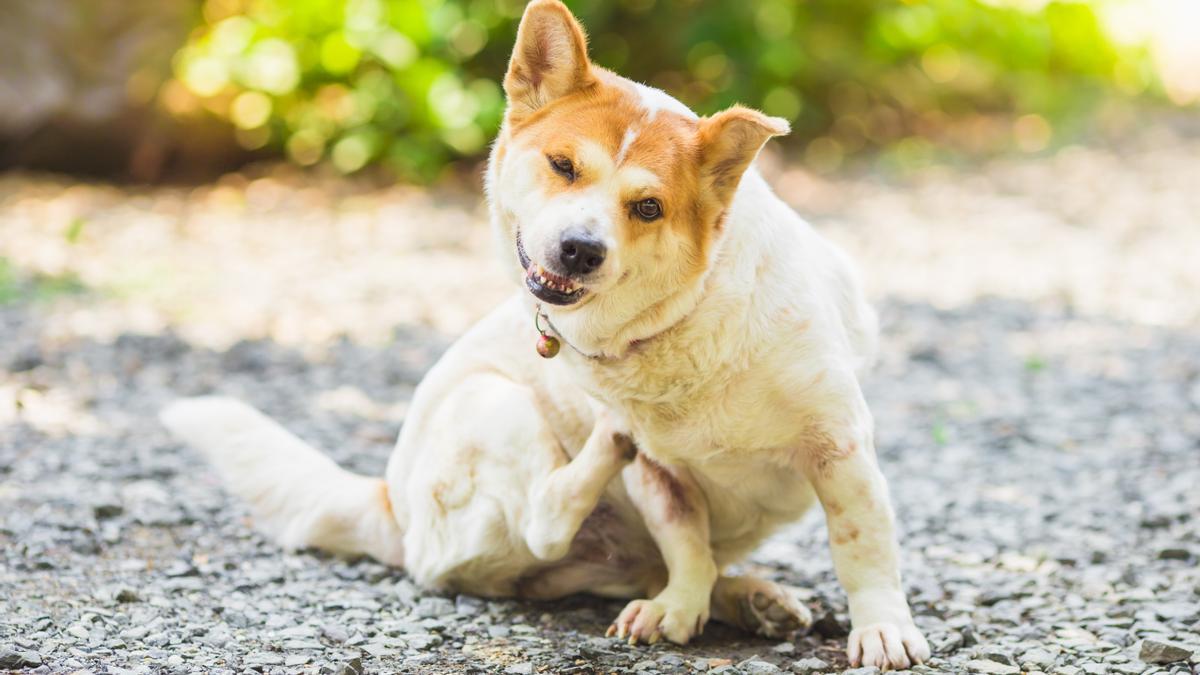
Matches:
[810,434,930,670]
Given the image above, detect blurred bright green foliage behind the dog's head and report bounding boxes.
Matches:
[164,0,1148,179]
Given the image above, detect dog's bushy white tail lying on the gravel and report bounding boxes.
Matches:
[160,396,403,566]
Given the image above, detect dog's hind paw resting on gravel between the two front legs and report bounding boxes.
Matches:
[713,577,812,638]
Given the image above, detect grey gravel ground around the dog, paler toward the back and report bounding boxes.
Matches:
[0,124,1200,674]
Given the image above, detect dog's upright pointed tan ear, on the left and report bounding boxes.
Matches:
[504,0,593,120]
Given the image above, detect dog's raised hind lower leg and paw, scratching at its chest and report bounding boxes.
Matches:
[524,413,637,562]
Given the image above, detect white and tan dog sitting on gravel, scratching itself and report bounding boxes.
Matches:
[163,0,929,668]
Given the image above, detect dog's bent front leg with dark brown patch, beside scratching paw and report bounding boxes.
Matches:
[608,454,718,645]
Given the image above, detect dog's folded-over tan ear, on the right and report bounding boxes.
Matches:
[700,106,791,204]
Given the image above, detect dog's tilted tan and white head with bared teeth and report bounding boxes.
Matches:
[488,0,787,333]
